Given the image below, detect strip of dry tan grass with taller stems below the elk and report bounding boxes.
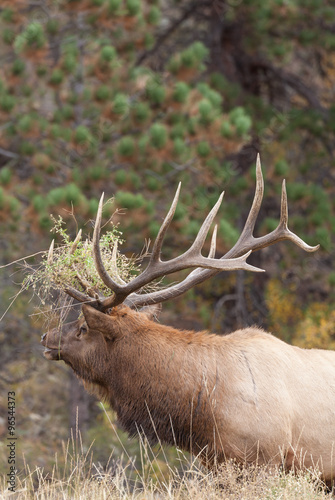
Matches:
[0,443,331,500]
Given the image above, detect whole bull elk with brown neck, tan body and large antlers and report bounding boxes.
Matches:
[41,158,335,482]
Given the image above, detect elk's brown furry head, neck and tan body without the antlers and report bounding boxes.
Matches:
[42,305,335,481]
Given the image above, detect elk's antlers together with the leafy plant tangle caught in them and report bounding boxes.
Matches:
[24,156,318,310]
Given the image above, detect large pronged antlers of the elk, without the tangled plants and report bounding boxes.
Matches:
[65,155,319,310]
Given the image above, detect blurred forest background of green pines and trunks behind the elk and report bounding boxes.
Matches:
[0,0,335,480]
